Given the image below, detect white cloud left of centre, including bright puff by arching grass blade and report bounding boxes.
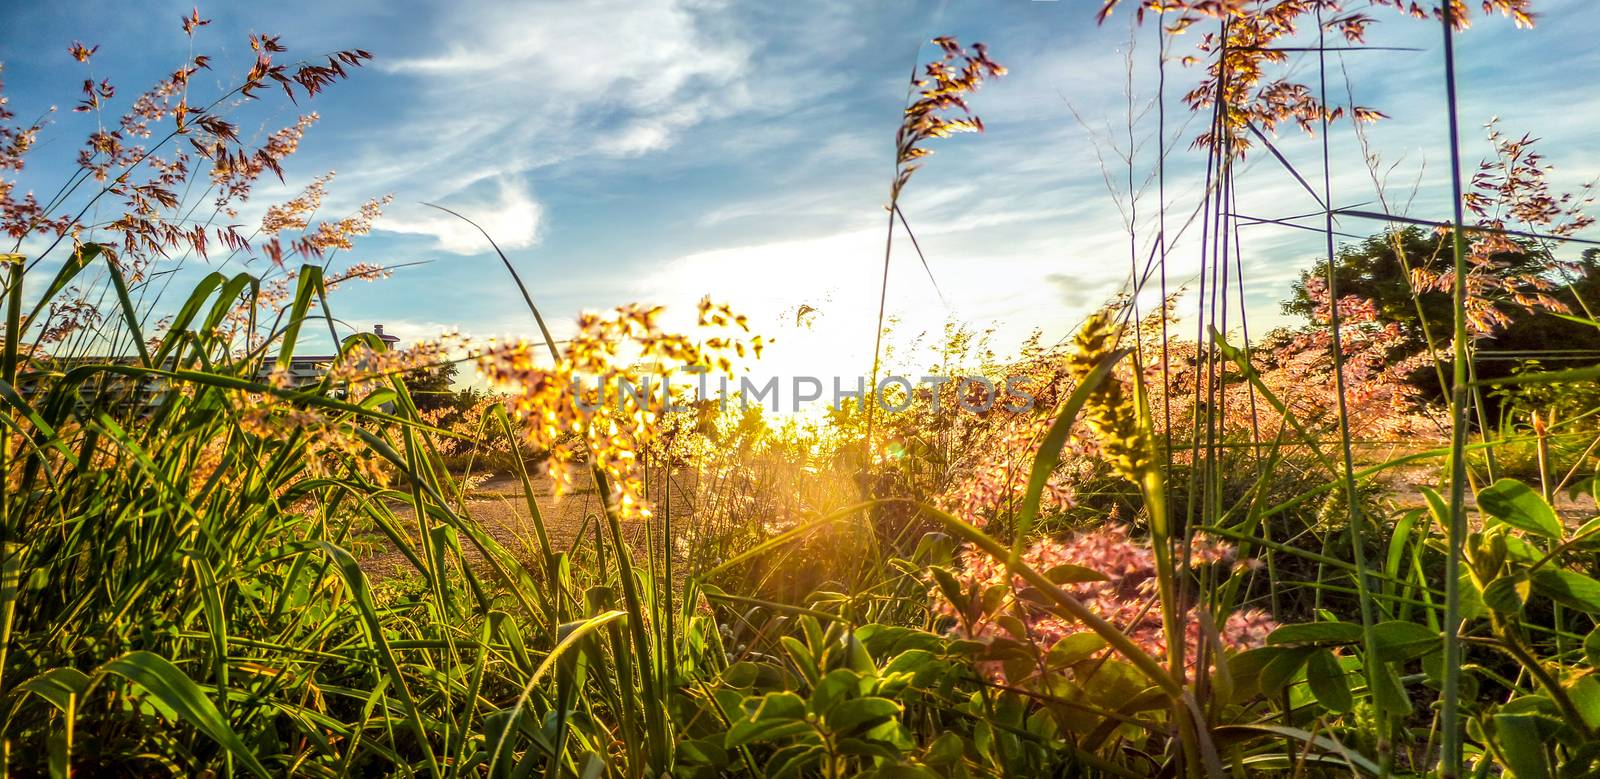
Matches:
[337,0,768,254]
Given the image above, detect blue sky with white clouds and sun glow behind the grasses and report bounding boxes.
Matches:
[0,0,1600,374]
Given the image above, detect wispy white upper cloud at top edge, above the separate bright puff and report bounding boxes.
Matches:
[384,0,750,166]
